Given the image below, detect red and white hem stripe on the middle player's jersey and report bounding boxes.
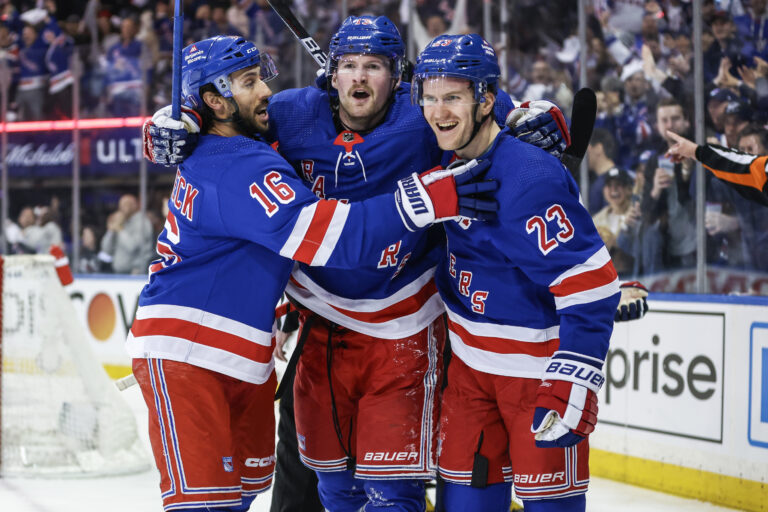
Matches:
[286,267,445,339]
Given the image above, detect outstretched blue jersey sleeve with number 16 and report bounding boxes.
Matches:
[213,150,407,268]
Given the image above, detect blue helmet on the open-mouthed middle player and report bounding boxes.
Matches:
[326,16,405,77]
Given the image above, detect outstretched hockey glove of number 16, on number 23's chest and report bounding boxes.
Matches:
[395,160,499,231]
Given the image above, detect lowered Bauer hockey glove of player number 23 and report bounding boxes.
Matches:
[531,352,605,448]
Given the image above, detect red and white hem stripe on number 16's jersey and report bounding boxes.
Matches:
[126,304,275,384]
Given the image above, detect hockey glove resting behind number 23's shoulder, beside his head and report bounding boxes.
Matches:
[506,100,571,158]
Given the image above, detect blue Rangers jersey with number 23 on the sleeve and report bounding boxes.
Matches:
[436,130,619,378]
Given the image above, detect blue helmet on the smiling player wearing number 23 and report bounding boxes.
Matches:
[411,34,501,103]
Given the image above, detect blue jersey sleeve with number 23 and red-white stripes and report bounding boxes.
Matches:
[492,154,620,366]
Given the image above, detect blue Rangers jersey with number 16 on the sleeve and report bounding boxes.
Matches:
[126,135,424,384]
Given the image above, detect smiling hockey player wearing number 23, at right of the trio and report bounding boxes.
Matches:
[412,34,619,512]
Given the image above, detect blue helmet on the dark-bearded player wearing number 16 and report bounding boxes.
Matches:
[181,36,277,111]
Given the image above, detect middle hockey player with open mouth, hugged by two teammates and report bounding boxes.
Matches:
[141,17,565,511]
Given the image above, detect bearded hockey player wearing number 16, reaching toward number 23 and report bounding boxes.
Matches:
[126,36,494,512]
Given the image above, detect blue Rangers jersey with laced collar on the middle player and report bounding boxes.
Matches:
[269,83,513,339]
